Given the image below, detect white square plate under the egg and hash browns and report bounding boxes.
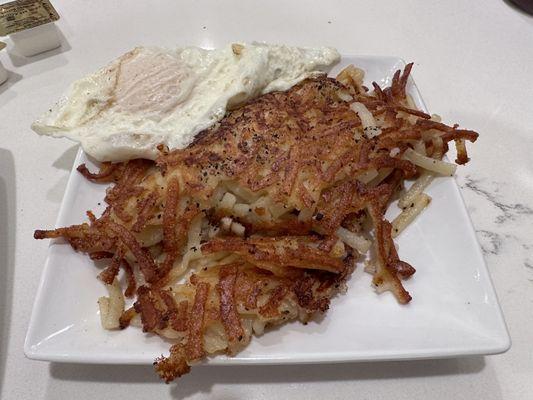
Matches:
[24,56,510,365]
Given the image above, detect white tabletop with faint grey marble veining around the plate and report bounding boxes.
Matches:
[0,0,533,400]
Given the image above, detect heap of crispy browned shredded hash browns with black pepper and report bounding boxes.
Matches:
[35,58,478,382]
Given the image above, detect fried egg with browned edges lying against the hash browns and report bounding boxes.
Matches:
[32,43,340,161]
